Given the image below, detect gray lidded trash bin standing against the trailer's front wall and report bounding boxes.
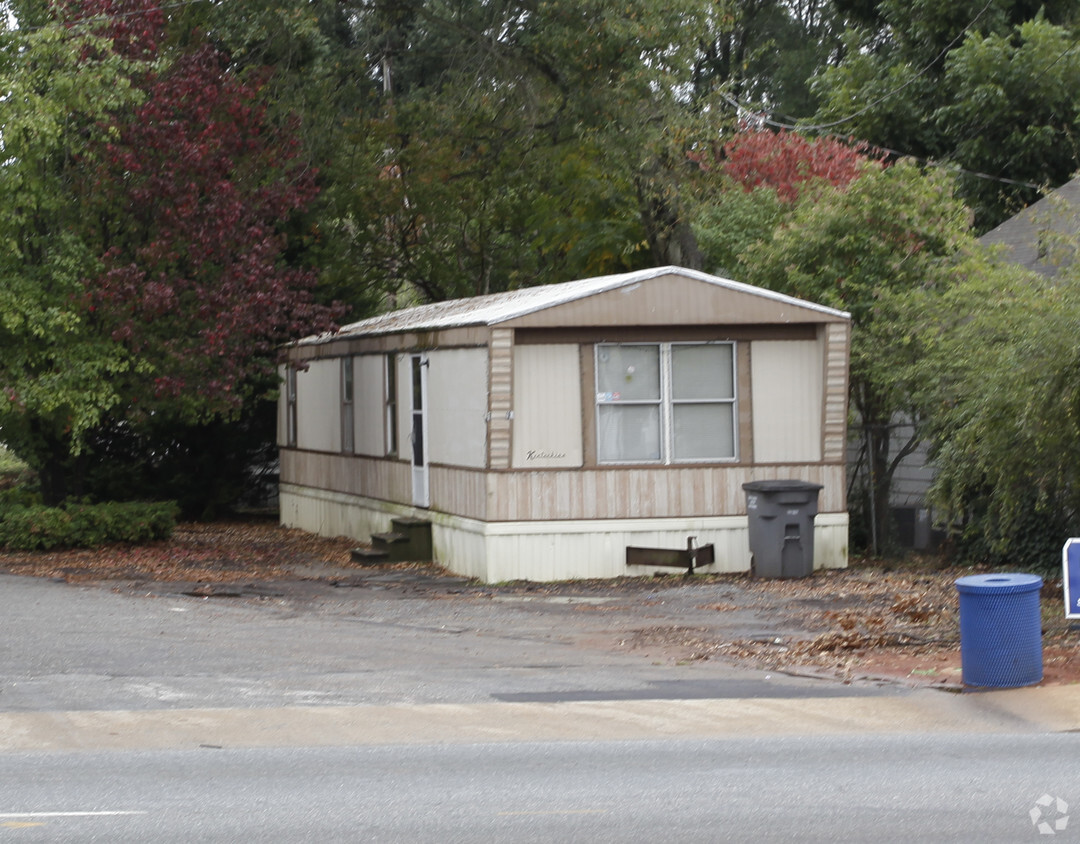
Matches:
[743,481,823,577]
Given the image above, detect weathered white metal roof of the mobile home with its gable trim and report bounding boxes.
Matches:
[293,266,851,346]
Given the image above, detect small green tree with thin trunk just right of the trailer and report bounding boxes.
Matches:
[747,161,975,545]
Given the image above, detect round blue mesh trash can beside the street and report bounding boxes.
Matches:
[956,574,1042,688]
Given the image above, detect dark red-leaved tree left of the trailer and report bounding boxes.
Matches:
[72,0,333,421]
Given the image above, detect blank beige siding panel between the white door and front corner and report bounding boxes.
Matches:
[428,349,488,466]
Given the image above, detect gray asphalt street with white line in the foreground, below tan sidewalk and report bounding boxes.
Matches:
[0,735,1080,844]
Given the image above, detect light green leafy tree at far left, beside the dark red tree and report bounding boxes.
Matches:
[0,14,143,499]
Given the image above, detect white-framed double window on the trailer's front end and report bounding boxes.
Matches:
[596,343,737,464]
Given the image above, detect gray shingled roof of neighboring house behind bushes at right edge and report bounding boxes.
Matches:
[978,178,1080,276]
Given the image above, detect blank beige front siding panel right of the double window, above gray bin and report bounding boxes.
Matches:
[751,340,823,464]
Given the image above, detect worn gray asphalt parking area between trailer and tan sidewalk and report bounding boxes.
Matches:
[0,575,881,712]
